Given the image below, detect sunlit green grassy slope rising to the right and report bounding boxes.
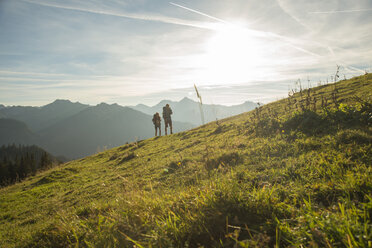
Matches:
[0,74,372,247]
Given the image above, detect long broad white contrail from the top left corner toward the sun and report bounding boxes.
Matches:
[22,0,212,29]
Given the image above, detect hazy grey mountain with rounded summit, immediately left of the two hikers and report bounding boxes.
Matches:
[40,103,193,158]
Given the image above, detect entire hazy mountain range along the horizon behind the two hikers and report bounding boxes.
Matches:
[0,98,256,159]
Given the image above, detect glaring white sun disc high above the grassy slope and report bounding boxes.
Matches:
[204,25,264,82]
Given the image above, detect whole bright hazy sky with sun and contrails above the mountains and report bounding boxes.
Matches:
[0,0,372,106]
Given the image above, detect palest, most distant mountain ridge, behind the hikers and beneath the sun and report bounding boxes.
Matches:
[131,97,257,125]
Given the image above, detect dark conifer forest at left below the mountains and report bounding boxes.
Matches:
[0,144,58,186]
